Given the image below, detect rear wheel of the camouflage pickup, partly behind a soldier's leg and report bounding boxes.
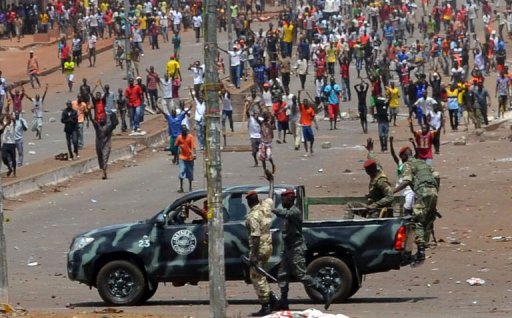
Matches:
[305,256,353,303]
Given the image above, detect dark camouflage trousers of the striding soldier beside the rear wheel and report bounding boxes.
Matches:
[277,244,316,293]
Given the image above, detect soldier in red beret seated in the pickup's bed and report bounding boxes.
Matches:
[345,159,393,219]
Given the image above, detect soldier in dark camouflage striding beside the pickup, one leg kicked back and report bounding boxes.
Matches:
[272,189,332,310]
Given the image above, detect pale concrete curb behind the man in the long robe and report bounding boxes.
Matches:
[3,121,167,199]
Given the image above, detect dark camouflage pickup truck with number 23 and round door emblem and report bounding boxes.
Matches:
[67,185,411,305]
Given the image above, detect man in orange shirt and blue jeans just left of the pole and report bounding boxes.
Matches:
[175,125,197,193]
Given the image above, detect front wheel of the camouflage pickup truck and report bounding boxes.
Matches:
[96,260,146,306]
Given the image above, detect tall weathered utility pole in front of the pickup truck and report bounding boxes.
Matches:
[203,0,226,318]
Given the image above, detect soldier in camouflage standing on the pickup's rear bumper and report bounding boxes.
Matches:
[394,146,439,262]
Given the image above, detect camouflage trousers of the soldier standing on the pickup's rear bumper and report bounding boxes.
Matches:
[412,188,437,245]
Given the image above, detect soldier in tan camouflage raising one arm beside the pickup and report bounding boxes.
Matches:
[245,170,275,317]
